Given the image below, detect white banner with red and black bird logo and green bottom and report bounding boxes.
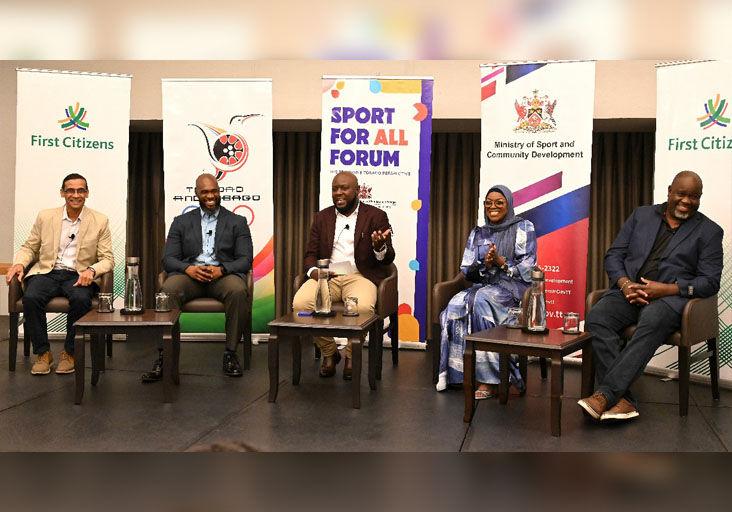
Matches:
[163,78,274,333]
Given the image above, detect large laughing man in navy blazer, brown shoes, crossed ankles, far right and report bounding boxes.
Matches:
[578,171,723,421]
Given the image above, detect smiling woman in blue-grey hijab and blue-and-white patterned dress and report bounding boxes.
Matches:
[437,185,536,400]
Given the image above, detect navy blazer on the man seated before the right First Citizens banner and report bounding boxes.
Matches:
[605,203,724,314]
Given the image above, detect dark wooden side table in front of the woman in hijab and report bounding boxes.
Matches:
[463,325,593,436]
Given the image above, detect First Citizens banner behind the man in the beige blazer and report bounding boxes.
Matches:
[14,69,132,333]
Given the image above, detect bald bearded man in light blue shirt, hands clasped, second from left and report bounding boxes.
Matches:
[142,174,253,382]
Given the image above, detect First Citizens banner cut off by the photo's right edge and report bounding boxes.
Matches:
[650,60,732,381]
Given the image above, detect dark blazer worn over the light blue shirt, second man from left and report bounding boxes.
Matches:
[163,206,254,279]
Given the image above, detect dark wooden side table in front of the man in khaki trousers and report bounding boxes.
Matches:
[267,312,380,409]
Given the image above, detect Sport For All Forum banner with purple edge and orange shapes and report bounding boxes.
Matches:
[320,76,434,348]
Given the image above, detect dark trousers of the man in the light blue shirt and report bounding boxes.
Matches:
[159,274,251,351]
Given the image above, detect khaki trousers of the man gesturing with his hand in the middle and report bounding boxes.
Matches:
[292,272,376,359]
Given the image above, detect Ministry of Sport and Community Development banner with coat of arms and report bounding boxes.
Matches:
[480,62,595,328]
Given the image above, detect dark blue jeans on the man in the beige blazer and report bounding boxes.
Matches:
[23,270,98,355]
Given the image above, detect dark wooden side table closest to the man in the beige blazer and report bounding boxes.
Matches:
[74,309,180,405]
